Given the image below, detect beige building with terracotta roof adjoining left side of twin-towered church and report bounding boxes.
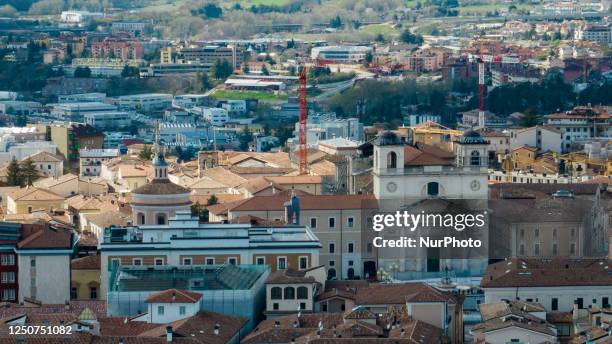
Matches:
[209,191,377,279]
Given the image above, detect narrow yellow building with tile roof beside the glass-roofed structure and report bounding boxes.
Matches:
[70,254,100,300]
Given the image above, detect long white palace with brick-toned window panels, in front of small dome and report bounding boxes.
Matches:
[99,211,321,295]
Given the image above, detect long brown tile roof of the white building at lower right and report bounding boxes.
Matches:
[481,258,612,288]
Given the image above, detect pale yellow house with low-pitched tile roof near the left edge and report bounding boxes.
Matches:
[6,186,66,214]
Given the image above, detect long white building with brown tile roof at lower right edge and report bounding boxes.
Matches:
[481,258,612,312]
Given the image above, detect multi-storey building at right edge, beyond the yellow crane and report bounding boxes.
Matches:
[545,106,612,152]
